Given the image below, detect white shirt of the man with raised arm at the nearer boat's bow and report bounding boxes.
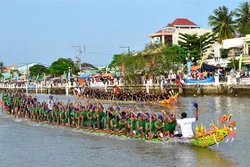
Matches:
[177,118,196,138]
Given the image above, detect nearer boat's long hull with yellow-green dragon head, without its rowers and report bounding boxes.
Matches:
[0,101,236,147]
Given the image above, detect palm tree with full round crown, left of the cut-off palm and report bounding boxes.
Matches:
[208,5,236,43]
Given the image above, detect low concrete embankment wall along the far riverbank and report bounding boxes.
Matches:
[0,84,250,96]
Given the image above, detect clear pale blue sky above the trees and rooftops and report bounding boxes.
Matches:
[0,0,243,66]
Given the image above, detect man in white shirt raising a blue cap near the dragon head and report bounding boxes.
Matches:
[177,103,198,138]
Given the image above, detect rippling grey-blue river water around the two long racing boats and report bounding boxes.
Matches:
[0,95,250,167]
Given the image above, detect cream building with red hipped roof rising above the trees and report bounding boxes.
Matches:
[148,18,212,46]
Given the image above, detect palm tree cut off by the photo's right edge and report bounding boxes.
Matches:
[235,1,250,36]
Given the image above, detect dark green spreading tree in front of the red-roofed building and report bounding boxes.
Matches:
[178,32,216,60]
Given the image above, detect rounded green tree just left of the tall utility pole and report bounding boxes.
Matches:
[49,58,79,76]
